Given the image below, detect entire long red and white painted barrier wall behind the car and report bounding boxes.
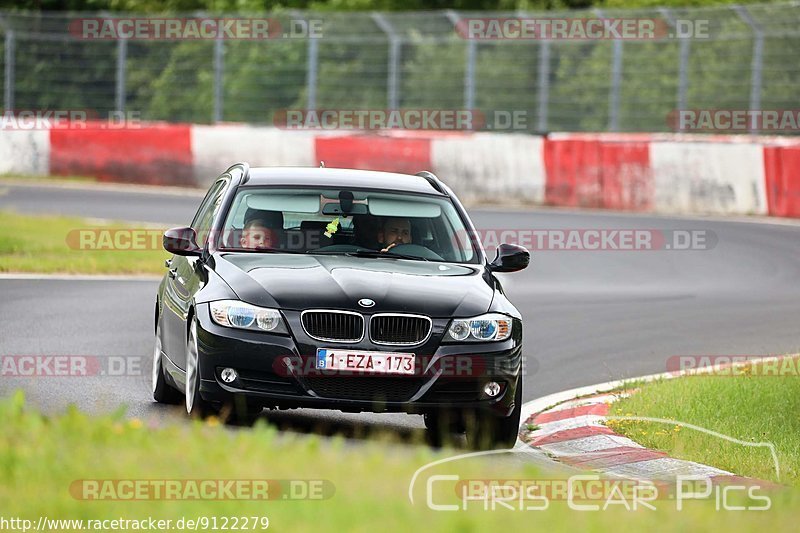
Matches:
[0,123,800,217]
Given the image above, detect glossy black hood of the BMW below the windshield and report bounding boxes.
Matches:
[213,253,494,318]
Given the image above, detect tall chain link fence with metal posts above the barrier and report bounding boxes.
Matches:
[0,3,800,132]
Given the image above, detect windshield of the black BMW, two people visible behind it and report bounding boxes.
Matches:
[220,187,478,263]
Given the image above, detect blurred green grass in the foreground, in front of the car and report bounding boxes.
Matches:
[0,393,800,532]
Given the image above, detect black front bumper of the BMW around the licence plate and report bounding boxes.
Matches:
[191,304,522,416]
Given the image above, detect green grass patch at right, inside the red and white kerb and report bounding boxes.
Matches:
[609,360,800,487]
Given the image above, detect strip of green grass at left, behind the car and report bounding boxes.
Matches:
[0,211,169,274]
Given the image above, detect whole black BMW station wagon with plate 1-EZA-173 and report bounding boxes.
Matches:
[153,163,530,448]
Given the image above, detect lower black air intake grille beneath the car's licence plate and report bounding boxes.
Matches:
[307,376,422,402]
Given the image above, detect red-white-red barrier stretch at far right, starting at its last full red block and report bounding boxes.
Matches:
[544,134,800,216]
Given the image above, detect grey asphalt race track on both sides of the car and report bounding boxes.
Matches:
[0,183,800,436]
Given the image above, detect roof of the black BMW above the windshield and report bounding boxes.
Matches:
[243,167,443,196]
